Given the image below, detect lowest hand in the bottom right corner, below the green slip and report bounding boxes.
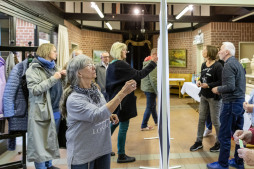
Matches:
[237,148,254,166]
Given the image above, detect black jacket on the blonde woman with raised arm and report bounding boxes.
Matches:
[106,60,156,122]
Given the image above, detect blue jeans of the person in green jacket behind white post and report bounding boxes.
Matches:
[141,92,158,128]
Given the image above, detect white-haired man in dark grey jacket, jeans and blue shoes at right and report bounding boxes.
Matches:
[207,42,246,169]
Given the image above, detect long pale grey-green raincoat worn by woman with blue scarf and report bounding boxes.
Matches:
[26,63,60,163]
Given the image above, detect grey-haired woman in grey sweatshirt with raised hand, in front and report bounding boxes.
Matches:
[62,55,136,169]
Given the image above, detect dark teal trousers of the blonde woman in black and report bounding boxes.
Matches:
[111,120,130,154]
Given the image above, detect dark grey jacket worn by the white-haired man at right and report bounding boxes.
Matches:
[218,56,246,102]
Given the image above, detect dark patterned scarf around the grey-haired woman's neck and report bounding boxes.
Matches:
[73,83,100,104]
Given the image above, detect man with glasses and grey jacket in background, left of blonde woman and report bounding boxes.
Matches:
[95,52,109,100]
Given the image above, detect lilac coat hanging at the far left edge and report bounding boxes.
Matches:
[0,56,6,118]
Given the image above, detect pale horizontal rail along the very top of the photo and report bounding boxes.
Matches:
[16,0,254,7]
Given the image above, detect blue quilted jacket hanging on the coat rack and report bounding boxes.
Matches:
[3,59,28,131]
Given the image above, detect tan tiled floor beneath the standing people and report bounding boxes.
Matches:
[0,90,254,169]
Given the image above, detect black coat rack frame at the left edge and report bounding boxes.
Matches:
[0,43,38,169]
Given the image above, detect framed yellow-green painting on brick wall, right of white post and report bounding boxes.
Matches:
[168,49,187,67]
